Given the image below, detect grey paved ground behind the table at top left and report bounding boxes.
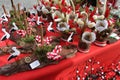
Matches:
[0,0,37,14]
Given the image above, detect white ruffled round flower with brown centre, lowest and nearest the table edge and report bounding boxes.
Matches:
[82,31,96,44]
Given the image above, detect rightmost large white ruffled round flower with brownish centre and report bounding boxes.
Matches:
[95,20,108,32]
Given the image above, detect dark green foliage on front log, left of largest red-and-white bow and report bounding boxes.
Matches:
[34,45,54,63]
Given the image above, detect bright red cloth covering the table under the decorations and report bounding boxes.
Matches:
[0,23,120,80]
